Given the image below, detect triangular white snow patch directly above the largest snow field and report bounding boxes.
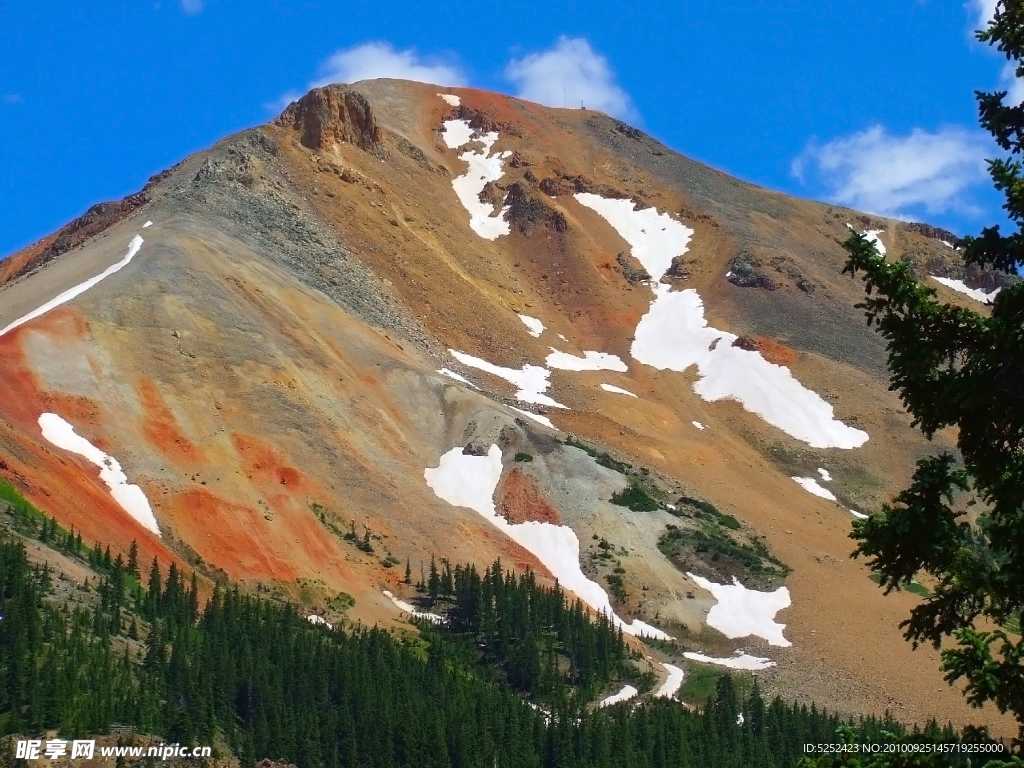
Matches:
[572,193,693,283]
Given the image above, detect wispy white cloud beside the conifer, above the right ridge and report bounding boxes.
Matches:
[791,126,991,218]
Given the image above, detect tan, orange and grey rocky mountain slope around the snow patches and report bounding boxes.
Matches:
[0,80,1007,737]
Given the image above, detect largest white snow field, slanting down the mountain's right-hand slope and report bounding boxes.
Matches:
[630,284,867,449]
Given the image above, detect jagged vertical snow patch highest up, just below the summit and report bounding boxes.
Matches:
[441,120,512,240]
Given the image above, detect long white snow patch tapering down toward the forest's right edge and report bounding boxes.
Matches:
[423,445,673,640]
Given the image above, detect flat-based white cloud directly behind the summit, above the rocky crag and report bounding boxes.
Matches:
[309,41,466,88]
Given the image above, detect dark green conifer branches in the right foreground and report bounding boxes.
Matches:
[844,0,1024,741]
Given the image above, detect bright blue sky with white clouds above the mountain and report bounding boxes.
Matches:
[0,0,1011,257]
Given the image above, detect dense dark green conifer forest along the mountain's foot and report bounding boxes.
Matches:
[0,537,1007,768]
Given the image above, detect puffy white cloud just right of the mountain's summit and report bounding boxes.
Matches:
[505,36,637,119]
